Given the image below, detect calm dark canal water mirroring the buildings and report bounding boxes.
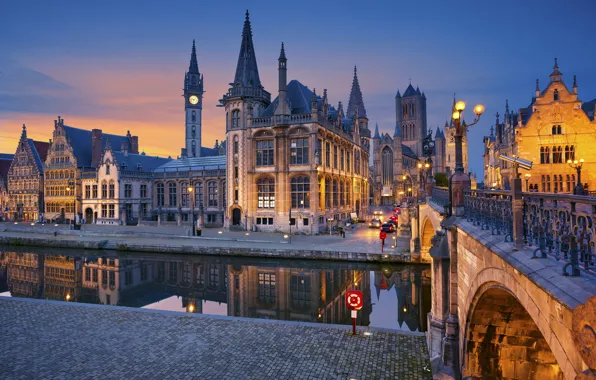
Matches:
[0,247,431,331]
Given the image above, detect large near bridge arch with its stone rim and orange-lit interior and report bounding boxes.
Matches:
[460,268,568,379]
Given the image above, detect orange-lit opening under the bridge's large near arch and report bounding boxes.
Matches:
[463,286,564,380]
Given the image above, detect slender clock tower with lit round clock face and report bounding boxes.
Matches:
[182,40,204,157]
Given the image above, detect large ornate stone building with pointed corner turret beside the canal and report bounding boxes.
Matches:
[220,12,371,234]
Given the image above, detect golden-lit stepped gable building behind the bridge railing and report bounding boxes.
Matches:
[484,58,596,194]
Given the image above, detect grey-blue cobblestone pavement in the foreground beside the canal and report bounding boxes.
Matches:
[0,297,432,380]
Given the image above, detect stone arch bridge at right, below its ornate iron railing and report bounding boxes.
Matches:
[422,193,596,380]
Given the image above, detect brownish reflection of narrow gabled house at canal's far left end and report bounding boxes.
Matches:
[4,252,44,298]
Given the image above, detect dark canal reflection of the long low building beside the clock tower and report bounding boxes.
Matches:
[155,258,228,313]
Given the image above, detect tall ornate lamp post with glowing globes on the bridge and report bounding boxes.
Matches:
[449,101,484,216]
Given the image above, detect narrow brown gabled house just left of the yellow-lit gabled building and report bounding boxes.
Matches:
[8,124,50,222]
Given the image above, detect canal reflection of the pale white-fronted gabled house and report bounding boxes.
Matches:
[82,257,154,306]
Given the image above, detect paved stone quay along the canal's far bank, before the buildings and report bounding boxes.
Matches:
[0,224,422,263]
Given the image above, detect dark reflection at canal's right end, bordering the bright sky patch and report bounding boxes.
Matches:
[375,267,431,331]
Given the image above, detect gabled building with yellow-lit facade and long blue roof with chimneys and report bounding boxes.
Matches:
[44,116,139,221]
